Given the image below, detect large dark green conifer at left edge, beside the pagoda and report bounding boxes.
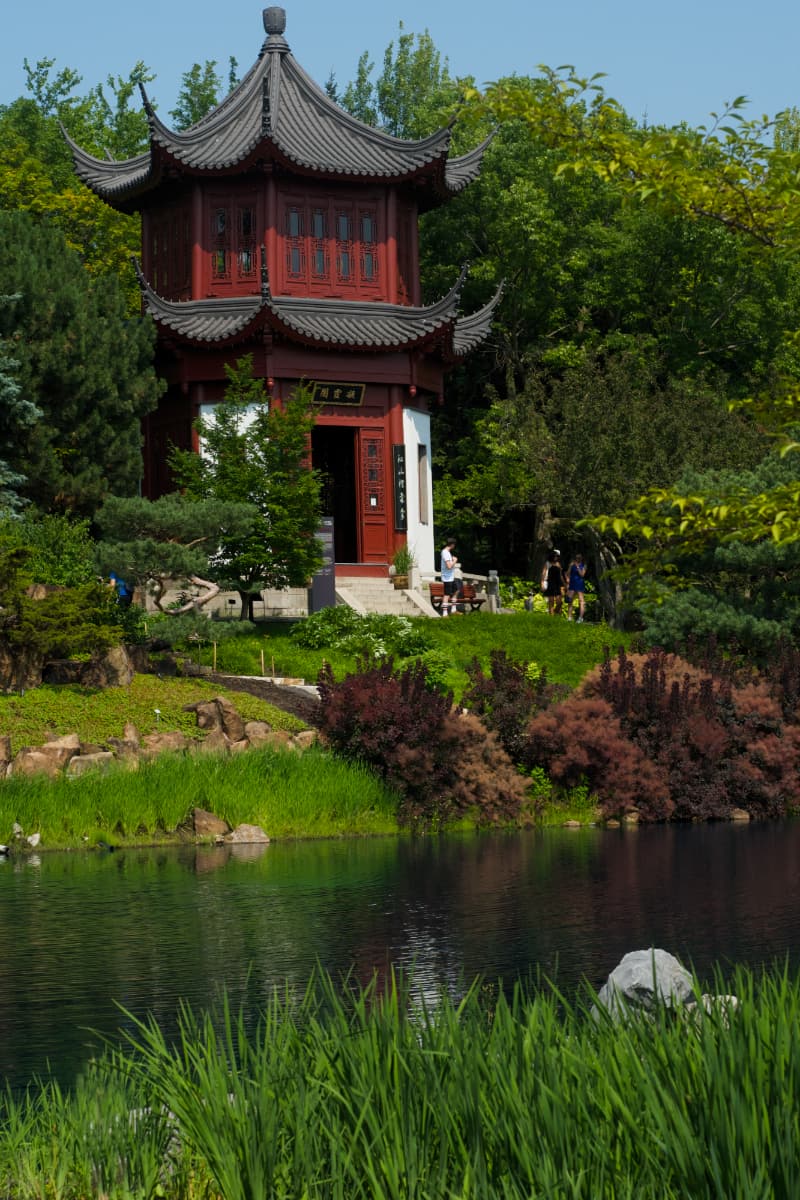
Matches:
[0,212,162,515]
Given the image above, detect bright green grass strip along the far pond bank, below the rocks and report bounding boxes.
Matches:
[0,748,397,848]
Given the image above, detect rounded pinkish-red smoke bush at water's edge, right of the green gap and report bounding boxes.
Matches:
[522,696,673,821]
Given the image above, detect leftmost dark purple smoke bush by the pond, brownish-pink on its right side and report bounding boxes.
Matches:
[318,659,527,828]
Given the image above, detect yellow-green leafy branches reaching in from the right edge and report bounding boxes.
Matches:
[462,68,800,561]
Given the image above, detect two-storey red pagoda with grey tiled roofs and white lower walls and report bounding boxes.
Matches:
[70,7,498,575]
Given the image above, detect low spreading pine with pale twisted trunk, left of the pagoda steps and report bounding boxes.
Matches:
[95,494,254,616]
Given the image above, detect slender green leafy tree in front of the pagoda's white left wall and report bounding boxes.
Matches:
[170,355,321,620]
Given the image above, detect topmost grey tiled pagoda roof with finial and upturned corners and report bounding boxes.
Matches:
[65,7,489,208]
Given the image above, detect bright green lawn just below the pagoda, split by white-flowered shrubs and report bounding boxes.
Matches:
[194,612,630,697]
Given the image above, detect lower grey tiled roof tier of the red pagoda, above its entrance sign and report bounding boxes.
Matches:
[137,264,500,359]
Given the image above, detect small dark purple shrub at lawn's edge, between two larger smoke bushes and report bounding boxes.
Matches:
[464,650,567,762]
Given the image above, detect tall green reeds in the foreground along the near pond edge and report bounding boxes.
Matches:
[0,970,800,1200]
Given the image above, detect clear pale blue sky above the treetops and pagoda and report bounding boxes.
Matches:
[0,0,800,125]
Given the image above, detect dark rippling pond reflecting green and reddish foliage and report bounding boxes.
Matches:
[0,822,800,1088]
